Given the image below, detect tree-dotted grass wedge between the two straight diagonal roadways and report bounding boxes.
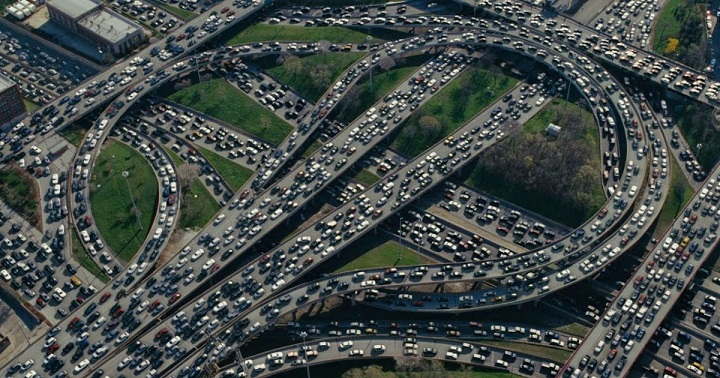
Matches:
[391,67,518,157]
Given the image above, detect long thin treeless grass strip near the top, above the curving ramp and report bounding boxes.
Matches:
[227,24,384,46]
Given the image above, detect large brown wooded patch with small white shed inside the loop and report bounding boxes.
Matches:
[466,100,605,227]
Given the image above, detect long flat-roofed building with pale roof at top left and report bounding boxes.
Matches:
[47,0,145,55]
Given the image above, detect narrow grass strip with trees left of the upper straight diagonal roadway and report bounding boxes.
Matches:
[336,55,429,124]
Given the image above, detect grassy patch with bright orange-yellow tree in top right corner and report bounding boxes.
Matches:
[651,0,708,69]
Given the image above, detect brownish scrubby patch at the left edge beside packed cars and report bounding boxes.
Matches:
[0,166,42,230]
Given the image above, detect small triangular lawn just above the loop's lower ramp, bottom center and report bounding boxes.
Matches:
[335,241,433,273]
